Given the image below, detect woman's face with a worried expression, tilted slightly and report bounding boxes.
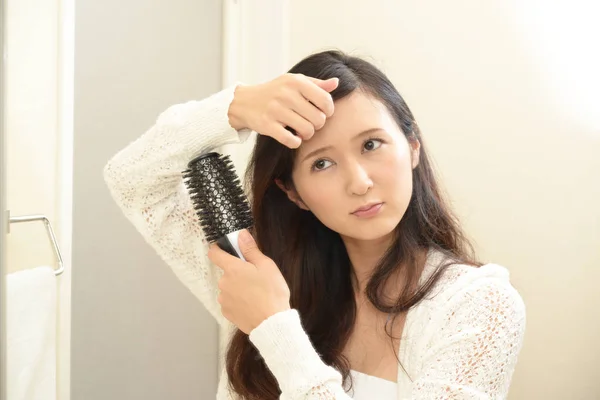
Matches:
[286,90,419,240]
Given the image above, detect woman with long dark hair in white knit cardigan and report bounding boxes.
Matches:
[104,51,525,400]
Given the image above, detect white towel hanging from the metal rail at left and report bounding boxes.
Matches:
[6,266,57,400]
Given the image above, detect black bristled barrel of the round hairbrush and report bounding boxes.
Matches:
[183,152,253,242]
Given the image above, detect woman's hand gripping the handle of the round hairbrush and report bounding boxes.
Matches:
[208,229,290,334]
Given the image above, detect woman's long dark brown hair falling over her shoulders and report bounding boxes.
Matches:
[226,51,481,400]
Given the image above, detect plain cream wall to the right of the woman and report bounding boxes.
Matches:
[289,0,600,400]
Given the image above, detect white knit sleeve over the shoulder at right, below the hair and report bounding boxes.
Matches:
[410,278,526,400]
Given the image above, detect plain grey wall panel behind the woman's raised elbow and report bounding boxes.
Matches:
[71,0,222,400]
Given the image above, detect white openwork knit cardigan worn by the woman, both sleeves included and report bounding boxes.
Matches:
[104,83,525,400]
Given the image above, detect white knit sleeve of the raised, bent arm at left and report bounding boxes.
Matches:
[103,85,250,325]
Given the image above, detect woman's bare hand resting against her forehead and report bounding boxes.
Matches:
[228,73,339,149]
